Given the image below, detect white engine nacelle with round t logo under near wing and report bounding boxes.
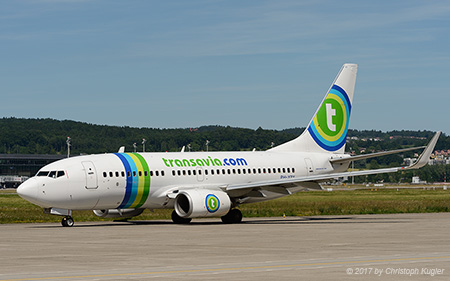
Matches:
[174,188,231,218]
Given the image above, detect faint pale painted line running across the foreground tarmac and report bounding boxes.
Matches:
[0,256,450,281]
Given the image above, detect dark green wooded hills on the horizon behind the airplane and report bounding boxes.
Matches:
[0,118,450,182]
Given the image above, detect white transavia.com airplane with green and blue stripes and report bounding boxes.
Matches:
[17,63,440,227]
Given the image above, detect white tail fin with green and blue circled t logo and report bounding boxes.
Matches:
[271,63,358,153]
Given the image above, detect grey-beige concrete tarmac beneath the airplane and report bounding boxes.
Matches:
[0,213,450,281]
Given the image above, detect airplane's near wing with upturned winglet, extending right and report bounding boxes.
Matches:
[224,132,441,191]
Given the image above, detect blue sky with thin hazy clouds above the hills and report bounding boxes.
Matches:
[0,0,450,135]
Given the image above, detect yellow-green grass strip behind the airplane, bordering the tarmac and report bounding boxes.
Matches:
[0,189,450,224]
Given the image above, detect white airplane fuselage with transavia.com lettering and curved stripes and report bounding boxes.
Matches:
[21,151,347,210]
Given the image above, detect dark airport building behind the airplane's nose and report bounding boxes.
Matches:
[0,154,67,188]
